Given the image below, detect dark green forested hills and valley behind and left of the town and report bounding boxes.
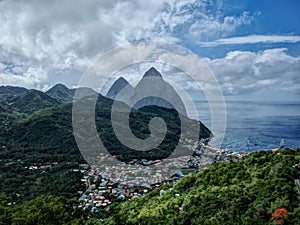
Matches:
[0,85,210,203]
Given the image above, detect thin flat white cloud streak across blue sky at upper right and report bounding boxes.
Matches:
[198,35,300,47]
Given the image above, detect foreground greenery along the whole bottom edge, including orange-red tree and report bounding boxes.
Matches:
[0,149,300,225]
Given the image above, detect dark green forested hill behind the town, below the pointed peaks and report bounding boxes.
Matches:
[0,96,210,161]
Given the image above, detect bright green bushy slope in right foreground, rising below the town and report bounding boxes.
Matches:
[101,149,300,225]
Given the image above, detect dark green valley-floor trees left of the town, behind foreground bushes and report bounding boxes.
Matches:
[0,162,84,203]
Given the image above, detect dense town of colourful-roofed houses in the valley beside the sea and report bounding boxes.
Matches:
[78,144,246,211]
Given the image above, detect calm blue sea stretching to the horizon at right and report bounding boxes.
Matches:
[196,101,300,152]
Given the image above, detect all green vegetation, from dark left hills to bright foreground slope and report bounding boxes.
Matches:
[0,87,300,225]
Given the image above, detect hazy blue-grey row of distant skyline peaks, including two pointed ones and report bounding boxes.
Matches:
[0,67,186,115]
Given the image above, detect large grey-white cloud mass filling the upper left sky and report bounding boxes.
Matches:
[0,0,203,88]
